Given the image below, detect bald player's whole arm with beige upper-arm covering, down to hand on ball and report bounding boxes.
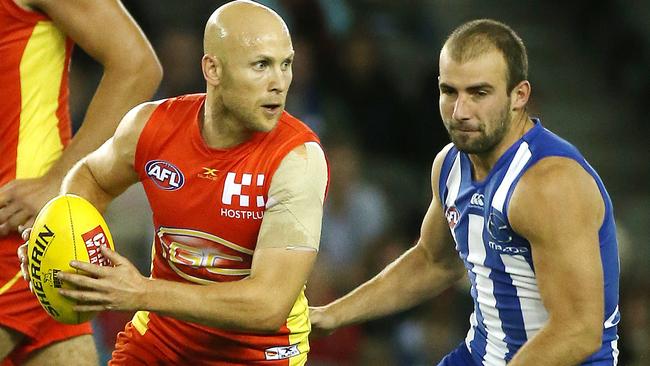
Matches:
[61,142,327,332]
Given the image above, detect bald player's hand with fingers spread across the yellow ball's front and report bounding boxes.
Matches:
[58,246,149,312]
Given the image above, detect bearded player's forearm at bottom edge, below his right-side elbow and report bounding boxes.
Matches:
[508,322,601,366]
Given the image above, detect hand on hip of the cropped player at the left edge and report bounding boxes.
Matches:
[0,176,61,237]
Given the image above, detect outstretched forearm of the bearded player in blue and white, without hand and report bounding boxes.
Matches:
[326,246,456,328]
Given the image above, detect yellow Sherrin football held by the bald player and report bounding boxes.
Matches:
[27,194,114,324]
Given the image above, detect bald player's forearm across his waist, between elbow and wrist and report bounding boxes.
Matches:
[139,278,293,332]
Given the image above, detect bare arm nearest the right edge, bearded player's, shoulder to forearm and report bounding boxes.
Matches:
[509,157,605,366]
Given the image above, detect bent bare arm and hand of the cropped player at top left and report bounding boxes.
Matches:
[0,0,162,235]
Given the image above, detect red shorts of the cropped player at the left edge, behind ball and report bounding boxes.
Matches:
[0,235,92,365]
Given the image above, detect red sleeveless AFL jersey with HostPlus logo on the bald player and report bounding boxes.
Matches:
[132,94,319,365]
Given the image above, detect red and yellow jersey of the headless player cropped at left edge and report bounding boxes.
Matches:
[0,0,73,185]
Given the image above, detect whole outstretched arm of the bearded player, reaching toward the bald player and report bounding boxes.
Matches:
[310,146,465,331]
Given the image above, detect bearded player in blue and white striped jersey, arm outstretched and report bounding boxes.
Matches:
[310,19,620,366]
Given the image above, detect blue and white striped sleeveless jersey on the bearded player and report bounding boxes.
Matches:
[438,119,620,365]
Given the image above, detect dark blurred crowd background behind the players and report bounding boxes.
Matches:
[71,0,650,365]
